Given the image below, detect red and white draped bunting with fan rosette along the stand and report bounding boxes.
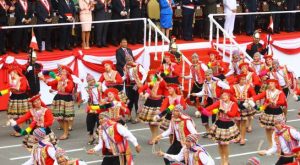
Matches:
[0,48,150,104]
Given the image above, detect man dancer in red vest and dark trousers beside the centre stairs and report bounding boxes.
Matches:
[183,53,208,117]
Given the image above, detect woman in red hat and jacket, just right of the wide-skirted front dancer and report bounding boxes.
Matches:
[231,74,256,145]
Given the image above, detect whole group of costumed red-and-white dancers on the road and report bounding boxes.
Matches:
[4,32,300,165]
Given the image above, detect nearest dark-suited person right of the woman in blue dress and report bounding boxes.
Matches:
[182,0,195,41]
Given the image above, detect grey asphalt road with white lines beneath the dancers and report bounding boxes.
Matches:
[0,98,300,165]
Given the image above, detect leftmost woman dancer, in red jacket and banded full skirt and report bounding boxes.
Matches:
[7,66,31,137]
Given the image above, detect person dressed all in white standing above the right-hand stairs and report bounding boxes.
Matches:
[223,0,237,37]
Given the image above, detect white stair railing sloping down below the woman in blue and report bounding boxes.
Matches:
[148,19,192,95]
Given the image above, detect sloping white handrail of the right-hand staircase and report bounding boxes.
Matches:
[208,14,252,61]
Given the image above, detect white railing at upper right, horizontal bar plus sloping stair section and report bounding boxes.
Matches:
[208,10,300,61]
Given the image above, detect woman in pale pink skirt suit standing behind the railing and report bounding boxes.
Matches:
[79,0,96,49]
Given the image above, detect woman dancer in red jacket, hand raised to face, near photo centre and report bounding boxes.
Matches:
[139,70,167,145]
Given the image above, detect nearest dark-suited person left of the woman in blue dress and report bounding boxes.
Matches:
[129,0,146,44]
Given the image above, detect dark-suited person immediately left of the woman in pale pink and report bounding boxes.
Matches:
[58,0,75,51]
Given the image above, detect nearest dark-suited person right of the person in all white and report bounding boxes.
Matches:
[243,0,258,36]
